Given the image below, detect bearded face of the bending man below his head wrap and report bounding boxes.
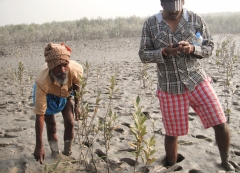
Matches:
[51,62,69,84]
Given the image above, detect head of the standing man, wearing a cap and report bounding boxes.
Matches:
[161,0,184,19]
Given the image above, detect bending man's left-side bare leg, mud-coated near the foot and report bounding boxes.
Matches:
[45,115,59,154]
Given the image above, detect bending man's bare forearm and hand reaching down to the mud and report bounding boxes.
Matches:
[34,115,45,164]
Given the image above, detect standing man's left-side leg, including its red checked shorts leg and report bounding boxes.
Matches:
[158,90,189,166]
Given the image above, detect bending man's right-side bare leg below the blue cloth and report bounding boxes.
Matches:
[62,99,74,156]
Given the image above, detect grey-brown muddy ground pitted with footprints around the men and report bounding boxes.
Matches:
[0,36,240,173]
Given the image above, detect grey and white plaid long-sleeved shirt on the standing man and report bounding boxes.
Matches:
[138,9,214,94]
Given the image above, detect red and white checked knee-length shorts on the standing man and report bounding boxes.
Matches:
[157,79,226,136]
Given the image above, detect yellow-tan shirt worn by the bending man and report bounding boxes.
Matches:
[33,60,83,115]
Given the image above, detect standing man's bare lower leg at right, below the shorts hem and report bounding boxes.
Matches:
[213,123,235,171]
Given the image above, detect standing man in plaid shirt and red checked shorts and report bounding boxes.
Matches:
[139,0,234,171]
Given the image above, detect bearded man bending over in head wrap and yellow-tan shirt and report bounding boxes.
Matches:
[33,43,83,164]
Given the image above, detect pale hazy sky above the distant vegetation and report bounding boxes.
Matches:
[0,0,240,26]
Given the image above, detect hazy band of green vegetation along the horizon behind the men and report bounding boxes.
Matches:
[0,12,240,45]
